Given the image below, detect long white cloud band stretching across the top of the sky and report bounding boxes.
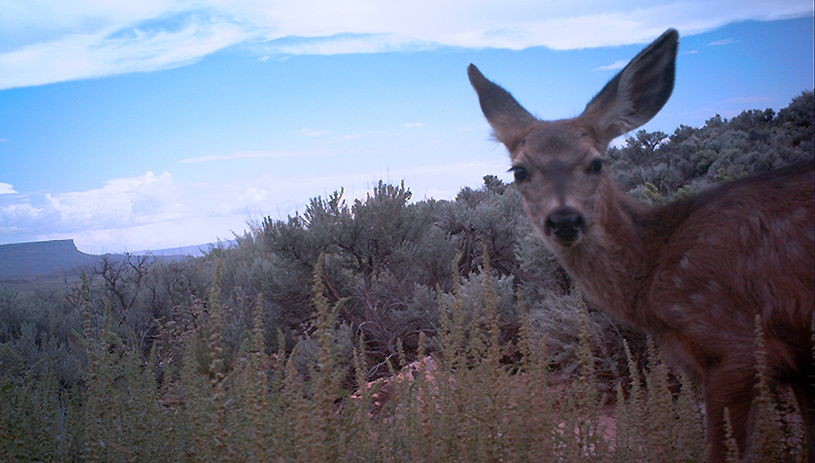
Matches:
[0,0,813,89]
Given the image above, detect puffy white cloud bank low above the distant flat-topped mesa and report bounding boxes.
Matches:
[0,172,256,252]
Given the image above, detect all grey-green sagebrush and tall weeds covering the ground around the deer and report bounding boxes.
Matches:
[0,92,815,461]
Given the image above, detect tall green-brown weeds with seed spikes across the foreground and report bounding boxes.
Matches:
[0,259,805,462]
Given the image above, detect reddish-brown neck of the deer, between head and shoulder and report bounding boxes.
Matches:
[556,182,681,329]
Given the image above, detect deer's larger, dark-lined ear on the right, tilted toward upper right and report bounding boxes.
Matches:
[578,29,679,152]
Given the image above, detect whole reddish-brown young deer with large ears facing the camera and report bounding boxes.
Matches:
[467,29,815,463]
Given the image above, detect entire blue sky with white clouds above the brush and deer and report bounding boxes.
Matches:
[0,0,815,254]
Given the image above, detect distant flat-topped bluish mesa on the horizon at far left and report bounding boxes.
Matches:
[0,240,99,279]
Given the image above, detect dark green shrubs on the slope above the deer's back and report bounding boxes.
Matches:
[606,91,815,199]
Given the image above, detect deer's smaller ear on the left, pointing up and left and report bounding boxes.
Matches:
[467,64,537,152]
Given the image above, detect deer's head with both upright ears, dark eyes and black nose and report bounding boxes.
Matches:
[467,29,679,252]
